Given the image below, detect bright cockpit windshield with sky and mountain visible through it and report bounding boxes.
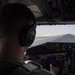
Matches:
[32,25,75,46]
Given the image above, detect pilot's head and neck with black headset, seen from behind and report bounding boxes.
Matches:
[0,3,36,57]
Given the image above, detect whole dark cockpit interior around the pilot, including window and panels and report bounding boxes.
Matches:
[0,0,75,75]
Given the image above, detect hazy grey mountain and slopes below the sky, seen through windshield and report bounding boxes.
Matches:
[31,34,75,47]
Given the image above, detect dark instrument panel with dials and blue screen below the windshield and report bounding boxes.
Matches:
[27,42,75,75]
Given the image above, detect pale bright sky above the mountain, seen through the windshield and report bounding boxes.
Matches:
[36,25,75,35]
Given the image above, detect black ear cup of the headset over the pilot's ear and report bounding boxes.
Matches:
[19,25,36,46]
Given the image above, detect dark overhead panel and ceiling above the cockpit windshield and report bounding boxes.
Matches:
[1,0,75,25]
